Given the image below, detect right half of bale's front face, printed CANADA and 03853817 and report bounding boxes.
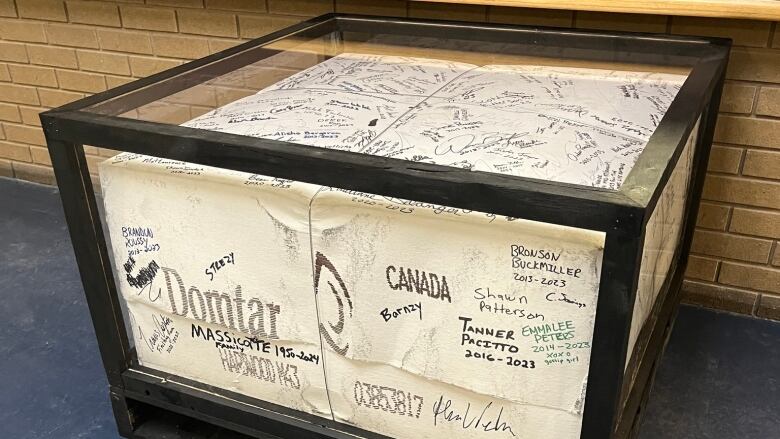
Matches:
[311,189,604,438]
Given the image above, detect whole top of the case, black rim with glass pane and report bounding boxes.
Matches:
[39,14,729,230]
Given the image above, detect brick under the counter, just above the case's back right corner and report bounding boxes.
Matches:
[672,17,772,47]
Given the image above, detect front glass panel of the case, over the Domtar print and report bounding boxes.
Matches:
[90,153,604,438]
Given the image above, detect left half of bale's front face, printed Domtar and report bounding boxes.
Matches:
[100,153,330,416]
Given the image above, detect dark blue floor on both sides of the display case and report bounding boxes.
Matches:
[0,178,780,439]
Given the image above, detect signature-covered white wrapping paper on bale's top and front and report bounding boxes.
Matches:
[100,54,684,438]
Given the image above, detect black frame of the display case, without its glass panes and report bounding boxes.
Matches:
[41,14,731,439]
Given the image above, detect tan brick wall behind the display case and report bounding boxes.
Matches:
[0,0,780,318]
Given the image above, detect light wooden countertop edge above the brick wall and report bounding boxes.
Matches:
[418,0,780,21]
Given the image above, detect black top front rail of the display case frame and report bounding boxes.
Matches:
[41,112,642,233]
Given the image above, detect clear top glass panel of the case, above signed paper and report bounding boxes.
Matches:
[87,28,688,190]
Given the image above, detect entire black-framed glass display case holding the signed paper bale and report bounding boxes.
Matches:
[41,15,730,439]
